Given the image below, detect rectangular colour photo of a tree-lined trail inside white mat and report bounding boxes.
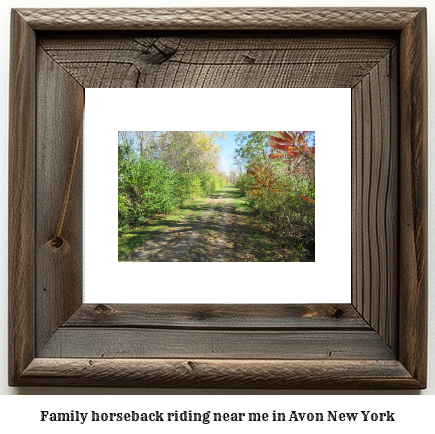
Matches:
[118,131,315,262]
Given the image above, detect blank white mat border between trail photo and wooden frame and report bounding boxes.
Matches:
[84,89,351,303]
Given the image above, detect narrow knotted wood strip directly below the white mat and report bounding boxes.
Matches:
[63,304,371,331]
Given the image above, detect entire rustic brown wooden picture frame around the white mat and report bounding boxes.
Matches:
[9,8,427,389]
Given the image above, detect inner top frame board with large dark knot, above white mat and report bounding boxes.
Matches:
[39,32,397,88]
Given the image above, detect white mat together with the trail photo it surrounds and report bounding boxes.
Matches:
[83,88,351,304]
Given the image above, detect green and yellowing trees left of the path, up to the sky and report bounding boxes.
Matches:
[118,131,225,232]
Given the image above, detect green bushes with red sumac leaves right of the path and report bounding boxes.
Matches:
[236,131,315,260]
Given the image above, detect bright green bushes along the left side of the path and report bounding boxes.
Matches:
[118,132,226,233]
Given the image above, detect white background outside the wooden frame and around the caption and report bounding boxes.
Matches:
[0,0,435,418]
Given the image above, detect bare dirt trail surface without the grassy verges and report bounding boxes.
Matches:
[126,187,255,262]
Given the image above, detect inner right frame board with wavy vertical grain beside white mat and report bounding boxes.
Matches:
[352,48,399,349]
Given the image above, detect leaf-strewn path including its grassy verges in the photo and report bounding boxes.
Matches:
[118,184,306,262]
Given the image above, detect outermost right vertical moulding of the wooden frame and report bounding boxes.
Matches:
[399,10,428,383]
